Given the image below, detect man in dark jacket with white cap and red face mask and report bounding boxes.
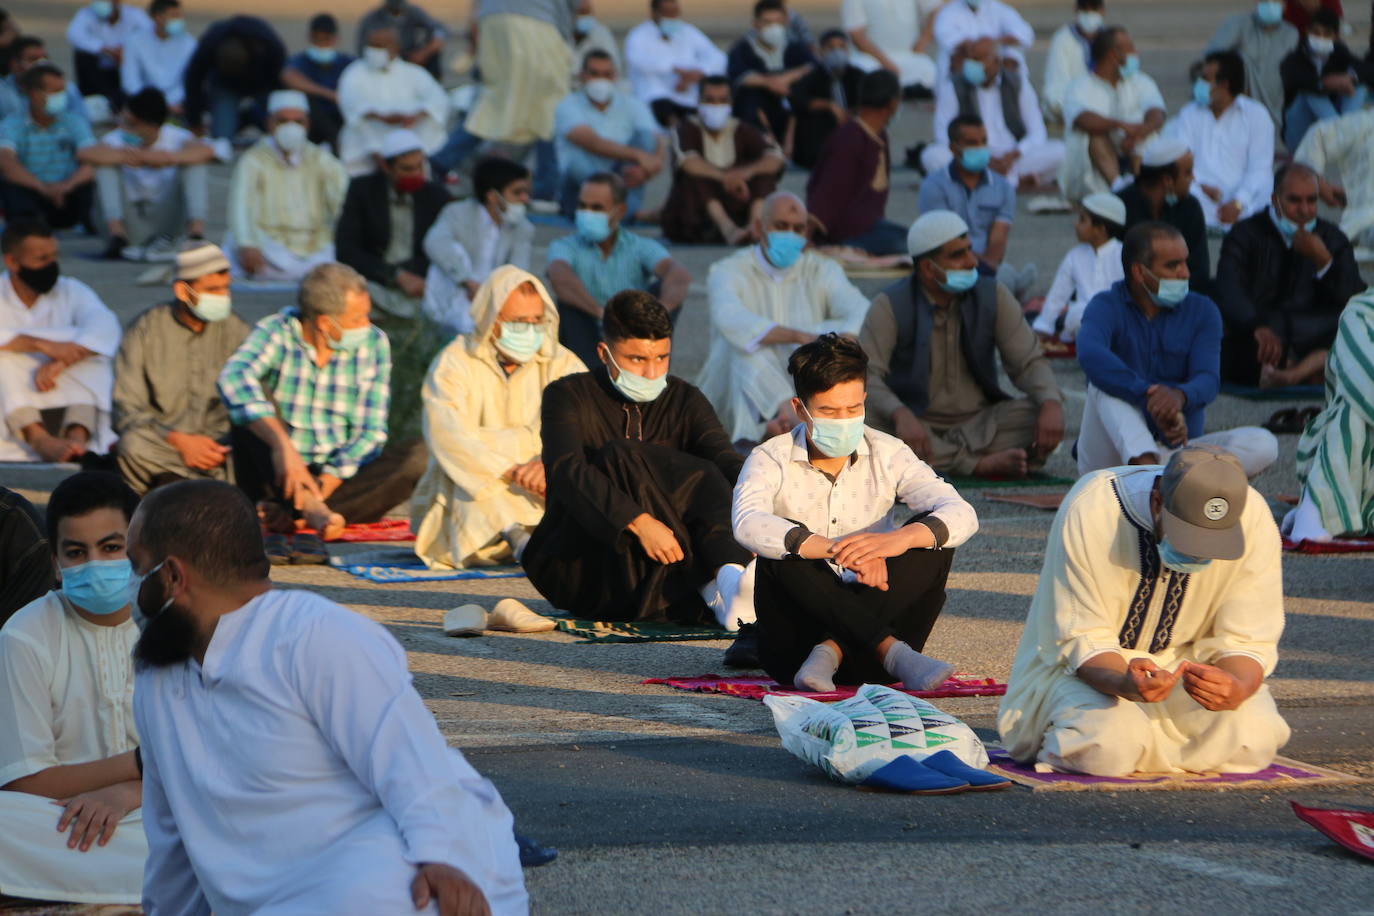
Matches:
[334,129,452,317]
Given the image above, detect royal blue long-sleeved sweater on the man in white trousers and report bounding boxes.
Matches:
[1077,282,1221,438]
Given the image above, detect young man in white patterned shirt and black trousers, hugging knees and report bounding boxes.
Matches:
[734,334,978,691]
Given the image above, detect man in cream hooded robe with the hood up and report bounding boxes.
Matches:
[411,265,587,569]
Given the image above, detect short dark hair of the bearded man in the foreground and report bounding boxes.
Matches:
[139,479,269,585]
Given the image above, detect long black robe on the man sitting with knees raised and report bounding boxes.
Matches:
[522,368,750,622]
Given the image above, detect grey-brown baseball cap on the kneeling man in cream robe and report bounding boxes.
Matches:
[1160,445,1250,560]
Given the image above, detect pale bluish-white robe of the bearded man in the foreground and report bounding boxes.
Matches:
[133,589,529,916]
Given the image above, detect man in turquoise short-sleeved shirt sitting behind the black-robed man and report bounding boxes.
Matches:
[548,172,691,365]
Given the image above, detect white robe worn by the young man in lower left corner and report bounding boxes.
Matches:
[0,592,148,904]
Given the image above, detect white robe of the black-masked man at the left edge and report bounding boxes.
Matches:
[0,273,120,461]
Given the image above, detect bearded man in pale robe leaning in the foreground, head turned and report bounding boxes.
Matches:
[129,481,529,916]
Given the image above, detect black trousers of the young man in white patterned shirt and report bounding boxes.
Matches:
[754,549,954,684]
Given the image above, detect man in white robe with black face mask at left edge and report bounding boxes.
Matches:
[0,220,120,461]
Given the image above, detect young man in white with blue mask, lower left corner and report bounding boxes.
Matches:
[0,471,148,904]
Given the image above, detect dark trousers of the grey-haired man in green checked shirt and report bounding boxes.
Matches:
[229,426,429,525]
